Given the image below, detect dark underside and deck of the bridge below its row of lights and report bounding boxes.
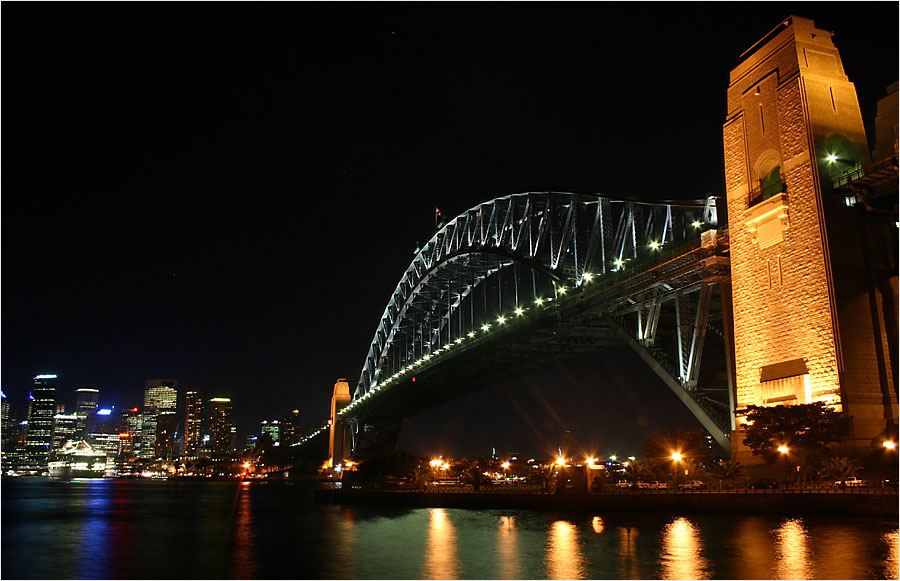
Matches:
[326,228,729,444]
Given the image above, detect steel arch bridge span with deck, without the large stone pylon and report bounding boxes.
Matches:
[298,192,734,454]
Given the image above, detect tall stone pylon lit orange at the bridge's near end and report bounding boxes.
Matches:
[724,17,897,452]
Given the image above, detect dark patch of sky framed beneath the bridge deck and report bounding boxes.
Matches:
[399,347,703,460]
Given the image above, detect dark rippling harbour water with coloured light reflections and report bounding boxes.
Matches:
[0,479,900,579]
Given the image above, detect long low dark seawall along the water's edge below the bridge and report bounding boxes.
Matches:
[319,490,898,518]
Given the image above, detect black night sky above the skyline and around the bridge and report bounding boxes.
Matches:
[2,2,898,455]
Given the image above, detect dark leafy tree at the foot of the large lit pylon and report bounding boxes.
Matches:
[744,402,850,463]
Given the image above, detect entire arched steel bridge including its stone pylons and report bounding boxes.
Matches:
[292,16,900,459]
